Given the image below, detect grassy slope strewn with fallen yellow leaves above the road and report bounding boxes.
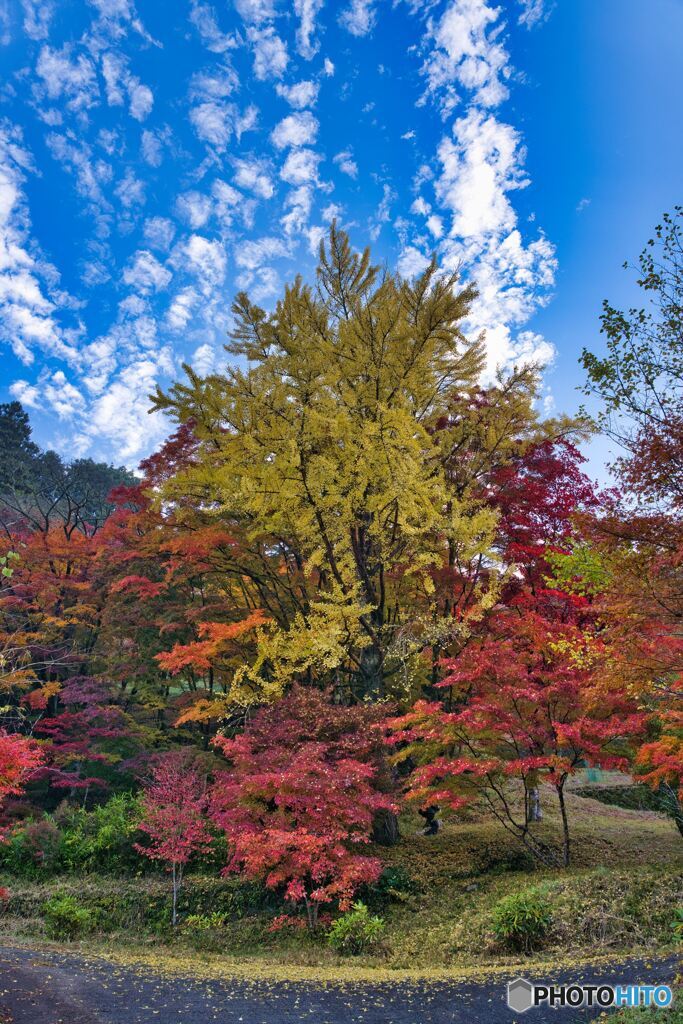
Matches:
[0,782,683,974]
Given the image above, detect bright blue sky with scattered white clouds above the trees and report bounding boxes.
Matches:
[0,0,683,471]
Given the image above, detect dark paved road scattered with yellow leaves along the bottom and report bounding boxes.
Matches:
[0,946,676,1024]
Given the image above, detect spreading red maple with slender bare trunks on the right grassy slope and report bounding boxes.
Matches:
[388,591,646,865]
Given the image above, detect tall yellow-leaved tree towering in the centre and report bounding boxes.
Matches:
[155,225,581,699]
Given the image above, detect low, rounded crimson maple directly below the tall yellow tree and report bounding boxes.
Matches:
[212,687,394,929]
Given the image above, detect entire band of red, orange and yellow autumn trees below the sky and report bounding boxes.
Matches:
[0,213,683,928]
